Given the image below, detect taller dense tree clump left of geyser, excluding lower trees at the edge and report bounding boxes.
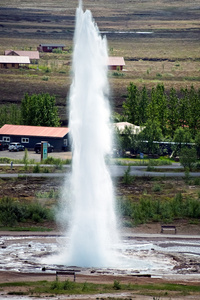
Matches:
[21,93,60,127]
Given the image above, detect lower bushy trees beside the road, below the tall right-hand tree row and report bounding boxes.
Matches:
[115,122,200,158]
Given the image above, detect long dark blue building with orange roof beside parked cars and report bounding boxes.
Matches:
[0,124,69,151]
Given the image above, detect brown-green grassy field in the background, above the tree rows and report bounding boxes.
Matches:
[0,0,200,124]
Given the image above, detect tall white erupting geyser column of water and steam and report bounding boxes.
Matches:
[60,2,117,267]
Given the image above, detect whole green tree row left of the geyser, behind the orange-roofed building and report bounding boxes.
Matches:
[0,93,60,127]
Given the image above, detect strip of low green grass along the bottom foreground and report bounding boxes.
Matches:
[0,280,200,300]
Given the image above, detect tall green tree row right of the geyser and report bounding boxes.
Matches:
[115,83,200,138]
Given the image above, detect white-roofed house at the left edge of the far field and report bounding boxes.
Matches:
[0,55,30,69]
